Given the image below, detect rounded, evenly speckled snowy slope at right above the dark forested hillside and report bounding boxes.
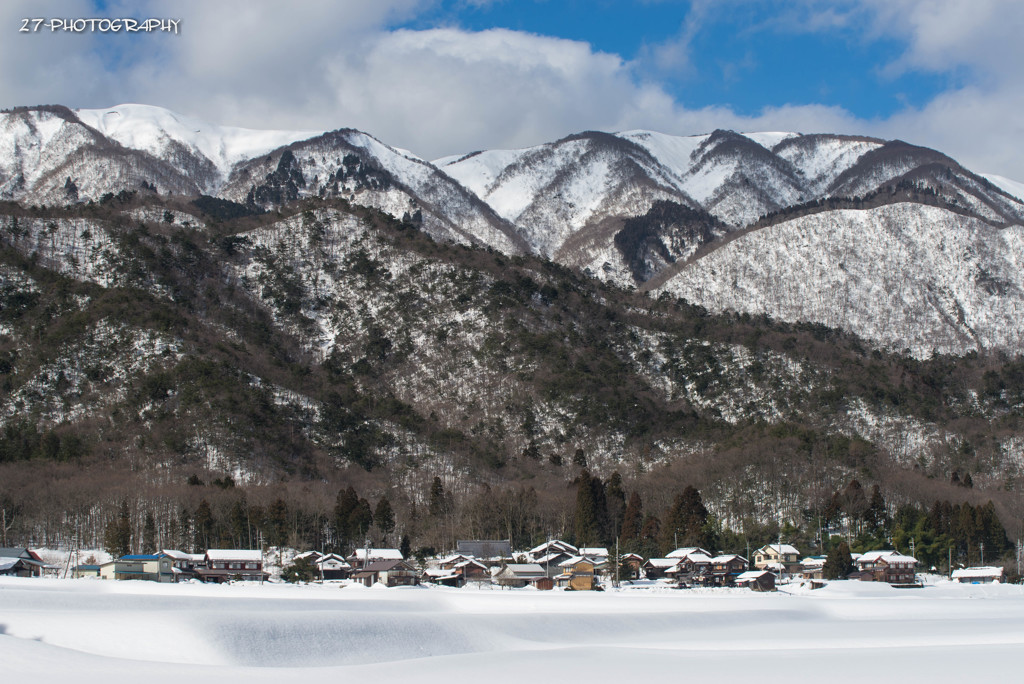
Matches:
[657,203,1024,357]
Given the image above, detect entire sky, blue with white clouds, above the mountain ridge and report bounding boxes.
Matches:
[6,0,1024,179]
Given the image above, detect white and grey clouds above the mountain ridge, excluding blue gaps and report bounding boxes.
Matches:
[6,0,1024,179]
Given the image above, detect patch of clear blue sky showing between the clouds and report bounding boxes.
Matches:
[402,0,957,118]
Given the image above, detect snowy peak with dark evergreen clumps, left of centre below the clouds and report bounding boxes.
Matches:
[221,129,526,254]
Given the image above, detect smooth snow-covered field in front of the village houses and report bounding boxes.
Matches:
[0,578,1024,684]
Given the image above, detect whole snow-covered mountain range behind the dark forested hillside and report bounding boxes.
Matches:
[6,104,1024,355]
